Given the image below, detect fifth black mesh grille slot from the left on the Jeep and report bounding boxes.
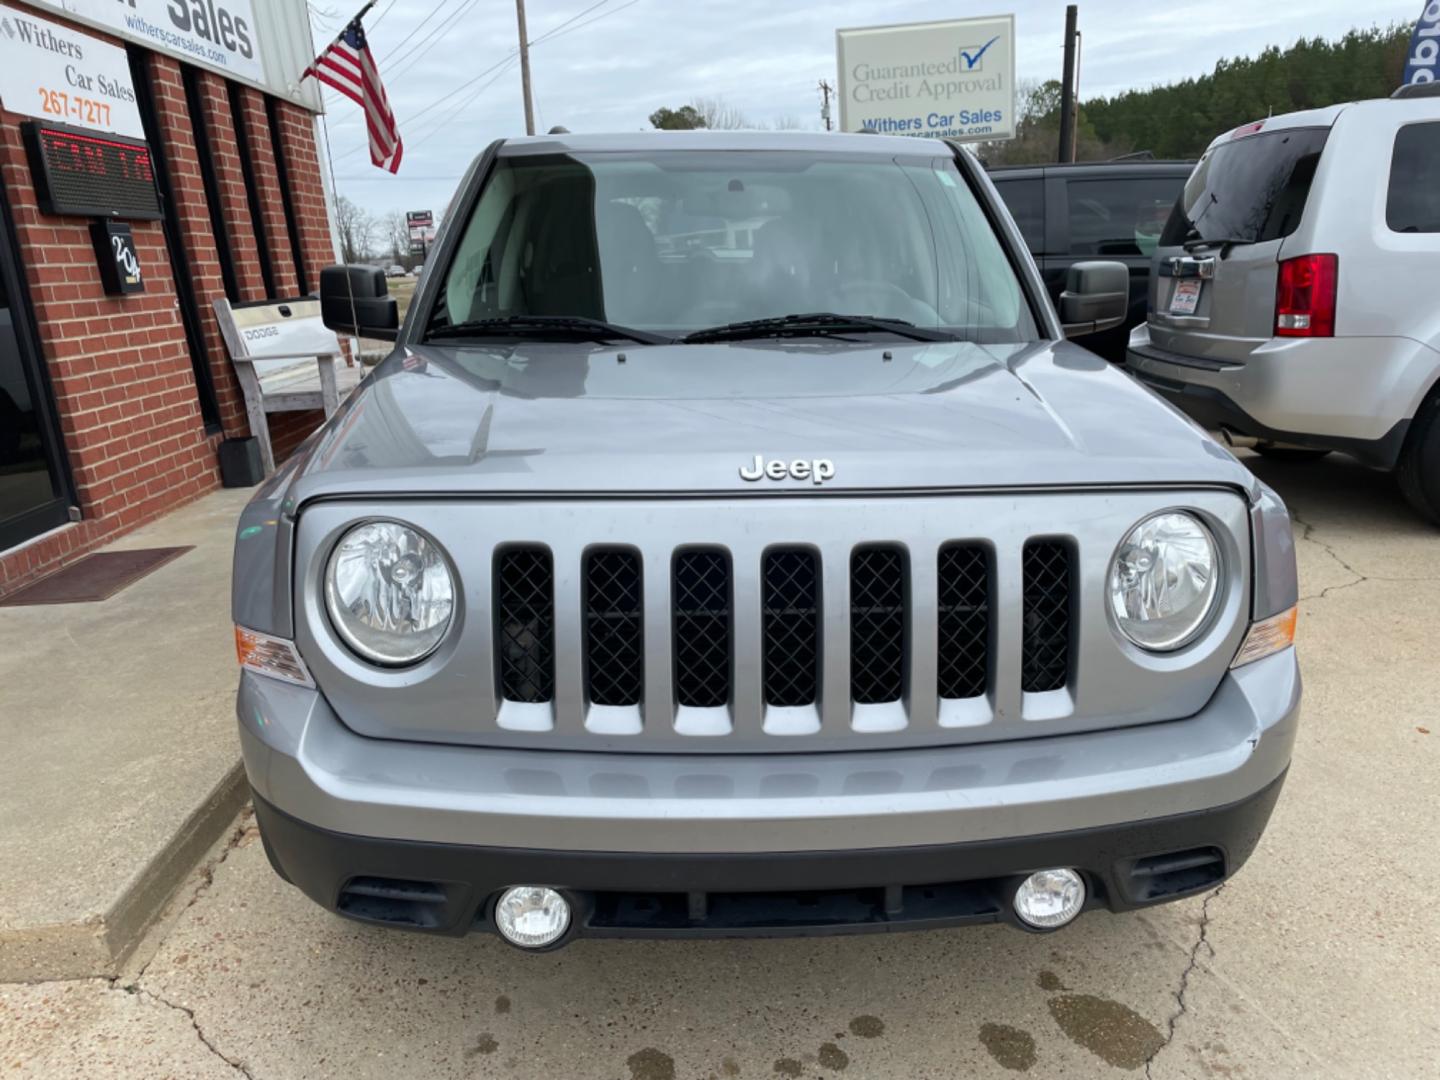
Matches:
[850,547,906,706]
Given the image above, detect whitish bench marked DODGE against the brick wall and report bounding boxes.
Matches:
[215,297,364,477]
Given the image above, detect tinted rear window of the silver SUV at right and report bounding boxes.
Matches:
[1161,128,1331,248]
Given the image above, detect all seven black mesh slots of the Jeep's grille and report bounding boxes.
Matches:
[495,540,1071,737]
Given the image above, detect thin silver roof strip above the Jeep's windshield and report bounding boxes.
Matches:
[500,130,955,157]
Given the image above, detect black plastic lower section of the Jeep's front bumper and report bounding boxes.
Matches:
[255,773,1284,945]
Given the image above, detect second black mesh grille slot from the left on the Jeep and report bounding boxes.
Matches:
[585,550,644,706]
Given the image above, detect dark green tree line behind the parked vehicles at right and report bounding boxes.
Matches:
[978,23,1411,166]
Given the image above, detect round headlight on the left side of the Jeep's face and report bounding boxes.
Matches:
[325,521,455,667]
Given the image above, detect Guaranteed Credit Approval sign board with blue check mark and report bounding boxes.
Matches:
[835,14,1015,140]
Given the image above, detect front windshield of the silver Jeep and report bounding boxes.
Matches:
[428,151,1037,341]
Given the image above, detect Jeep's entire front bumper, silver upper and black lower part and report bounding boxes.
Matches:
[238,649,1300,935]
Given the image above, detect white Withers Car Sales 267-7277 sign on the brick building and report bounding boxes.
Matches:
[0,4,145,138]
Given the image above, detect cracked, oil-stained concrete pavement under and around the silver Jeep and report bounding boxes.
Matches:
[0,456,1440,1080]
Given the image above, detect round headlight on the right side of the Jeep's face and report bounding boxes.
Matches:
[1110,510,1220,652]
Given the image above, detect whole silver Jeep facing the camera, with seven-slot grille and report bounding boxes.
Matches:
[233,132,1300,949]
